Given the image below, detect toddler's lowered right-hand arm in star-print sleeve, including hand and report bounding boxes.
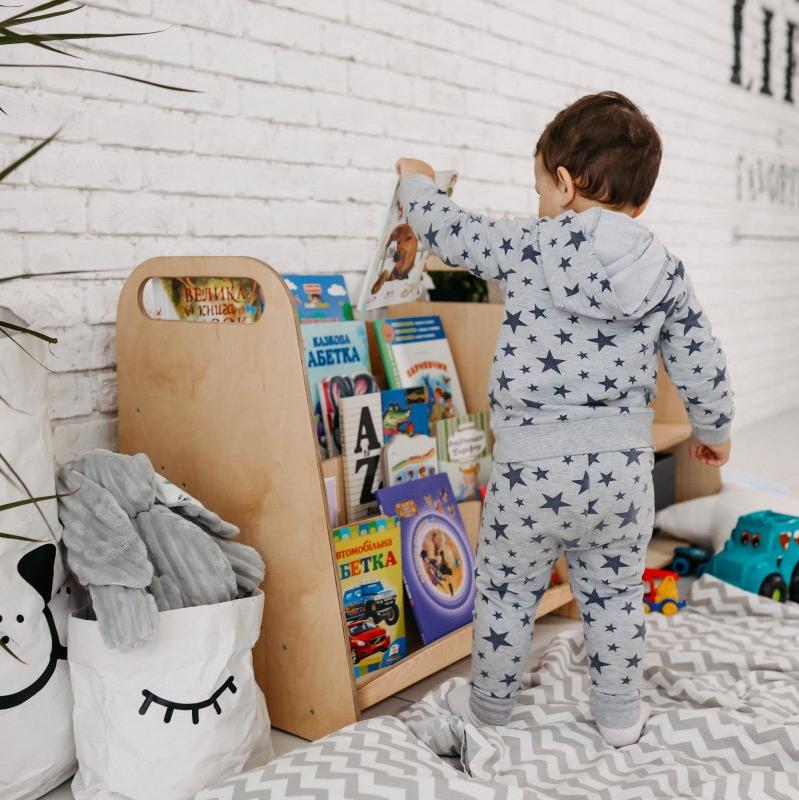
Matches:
[660,263,735,467]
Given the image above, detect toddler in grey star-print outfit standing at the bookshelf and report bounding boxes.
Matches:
[397,92,733,747]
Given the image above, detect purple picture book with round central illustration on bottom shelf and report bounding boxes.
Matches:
[377,473,474,644]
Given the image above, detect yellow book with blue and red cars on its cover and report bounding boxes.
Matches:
[332,516,407,678]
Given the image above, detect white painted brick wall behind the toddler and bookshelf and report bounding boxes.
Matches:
[0,0,799,459]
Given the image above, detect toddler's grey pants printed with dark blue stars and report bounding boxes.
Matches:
[470,448,655,728]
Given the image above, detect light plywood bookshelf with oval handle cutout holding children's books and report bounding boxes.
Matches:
[117,257,720,739]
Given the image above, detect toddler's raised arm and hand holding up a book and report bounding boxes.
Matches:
[397,158,539,281]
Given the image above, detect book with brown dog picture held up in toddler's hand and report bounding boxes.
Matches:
[358,171,458,311]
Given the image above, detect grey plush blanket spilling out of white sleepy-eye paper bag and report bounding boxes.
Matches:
[58,450,264,650]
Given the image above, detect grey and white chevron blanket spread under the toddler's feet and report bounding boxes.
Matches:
[197,576,799,800]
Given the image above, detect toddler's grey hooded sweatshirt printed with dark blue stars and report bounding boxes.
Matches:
[400,175,734,462]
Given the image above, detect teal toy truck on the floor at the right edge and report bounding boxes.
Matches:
[705,511,799,602]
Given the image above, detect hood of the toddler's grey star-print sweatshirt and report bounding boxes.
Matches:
[539,208,672,319]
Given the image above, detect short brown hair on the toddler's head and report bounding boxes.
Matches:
[535,92,663,208]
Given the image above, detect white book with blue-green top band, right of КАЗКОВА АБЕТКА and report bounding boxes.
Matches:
[372,316,466,423]
